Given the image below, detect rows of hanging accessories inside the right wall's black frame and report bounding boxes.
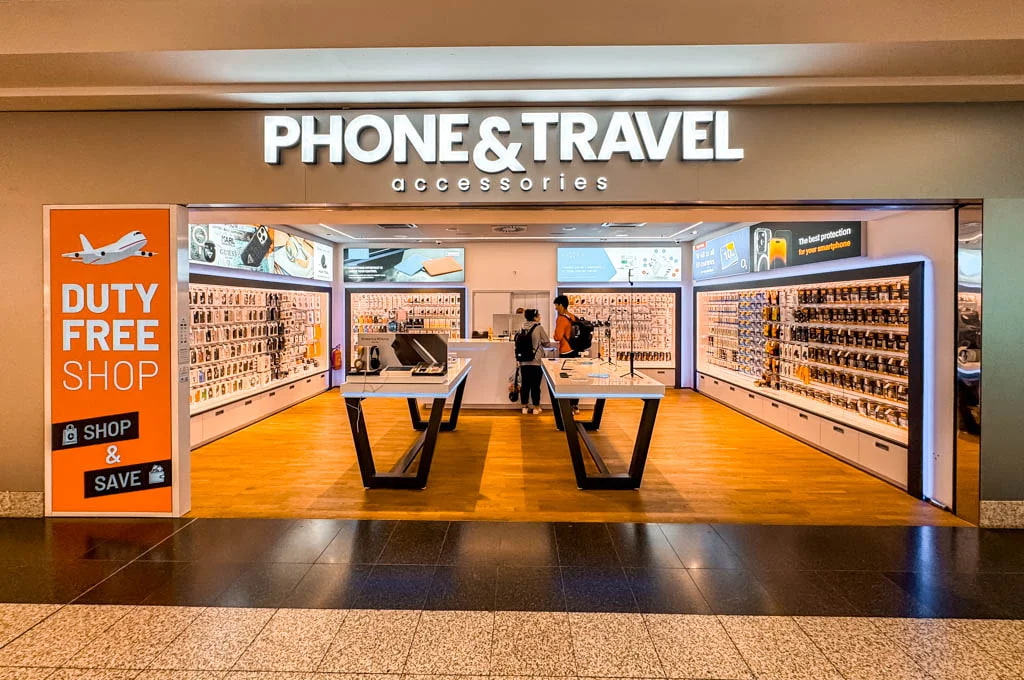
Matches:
[697,277,911,442]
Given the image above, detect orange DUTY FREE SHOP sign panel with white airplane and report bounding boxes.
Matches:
[47,208,187,515]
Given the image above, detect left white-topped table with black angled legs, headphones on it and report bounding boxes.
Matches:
[341,359,470,488]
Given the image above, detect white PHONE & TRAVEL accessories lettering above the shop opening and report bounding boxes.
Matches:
[263,110,743,200]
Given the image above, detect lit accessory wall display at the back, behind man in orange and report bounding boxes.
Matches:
[561,289,675,369]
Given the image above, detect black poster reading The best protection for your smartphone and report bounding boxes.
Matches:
[750,222,864,271]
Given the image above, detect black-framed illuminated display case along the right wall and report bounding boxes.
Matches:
[694,264,924,491]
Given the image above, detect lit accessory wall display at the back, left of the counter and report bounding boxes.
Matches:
[348,290,463,358]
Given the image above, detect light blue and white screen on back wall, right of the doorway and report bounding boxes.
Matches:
[558,247,683,284]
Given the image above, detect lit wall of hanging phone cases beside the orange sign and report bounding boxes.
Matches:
[188,284,328,413]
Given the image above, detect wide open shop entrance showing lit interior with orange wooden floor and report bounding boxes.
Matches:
[182,208,963,524]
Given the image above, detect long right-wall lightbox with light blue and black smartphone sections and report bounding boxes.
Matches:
[693,222,864,281]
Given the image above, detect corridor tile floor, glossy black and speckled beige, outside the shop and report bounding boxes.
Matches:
[0,519,1024,680]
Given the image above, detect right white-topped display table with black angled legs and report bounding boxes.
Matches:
[542,358,665,488]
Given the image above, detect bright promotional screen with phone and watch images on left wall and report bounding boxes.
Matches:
[188,224,334,281]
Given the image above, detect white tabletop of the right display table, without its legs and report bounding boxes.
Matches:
[541,358,665,399]
